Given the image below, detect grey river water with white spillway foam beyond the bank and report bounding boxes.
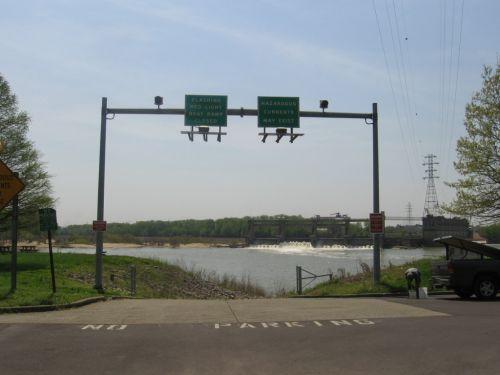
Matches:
[55,242,444,294]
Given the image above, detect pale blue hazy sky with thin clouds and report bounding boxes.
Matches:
[0,0,500,225]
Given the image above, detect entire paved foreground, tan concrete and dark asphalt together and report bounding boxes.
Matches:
[0,297,500,374]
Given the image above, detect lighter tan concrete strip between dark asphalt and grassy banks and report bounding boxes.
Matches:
[0,298,447,324]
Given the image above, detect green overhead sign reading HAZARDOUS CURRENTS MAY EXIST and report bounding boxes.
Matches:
[257,96,300,128]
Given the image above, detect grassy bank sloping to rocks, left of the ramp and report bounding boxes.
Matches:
[0,253,265,307]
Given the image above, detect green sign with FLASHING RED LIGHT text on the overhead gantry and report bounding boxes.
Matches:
[184,95,227,126]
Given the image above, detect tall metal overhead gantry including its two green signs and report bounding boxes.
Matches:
[95,95,381,290]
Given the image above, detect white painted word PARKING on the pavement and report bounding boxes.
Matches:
[214,319,375,329]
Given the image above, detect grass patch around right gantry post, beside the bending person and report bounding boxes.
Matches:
[303,259,438,296]
